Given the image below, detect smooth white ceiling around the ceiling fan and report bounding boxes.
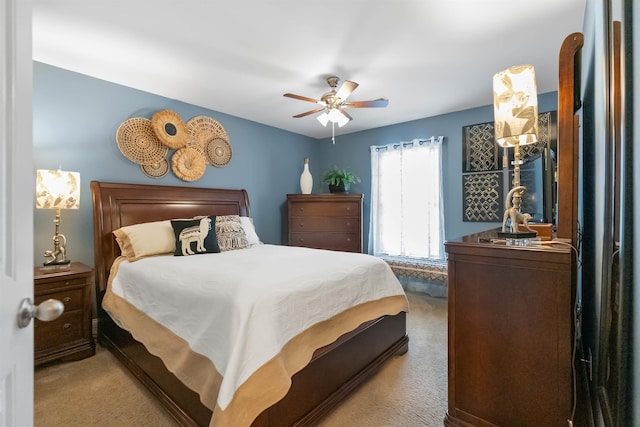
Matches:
[33,0,586,138]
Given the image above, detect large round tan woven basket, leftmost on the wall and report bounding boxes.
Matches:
[116,117,169,165]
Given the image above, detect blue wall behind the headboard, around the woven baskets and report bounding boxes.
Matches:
[33,62,320,266]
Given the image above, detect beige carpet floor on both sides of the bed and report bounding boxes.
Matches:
[34,292,447,427]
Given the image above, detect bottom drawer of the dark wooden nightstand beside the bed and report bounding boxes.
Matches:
[33,311,84,354]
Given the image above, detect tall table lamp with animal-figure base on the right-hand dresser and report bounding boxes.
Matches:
[493,65,538,238]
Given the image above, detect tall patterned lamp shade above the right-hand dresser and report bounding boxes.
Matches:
[493,65,538,147]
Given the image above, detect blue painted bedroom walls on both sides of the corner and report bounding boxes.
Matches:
[33,62,557,265]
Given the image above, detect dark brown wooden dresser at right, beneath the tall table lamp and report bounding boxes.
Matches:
[444,233,574,427]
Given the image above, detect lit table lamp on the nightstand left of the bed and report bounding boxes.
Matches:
[36,169,80,266]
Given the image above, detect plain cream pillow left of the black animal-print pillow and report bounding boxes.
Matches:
[113,220,176,261]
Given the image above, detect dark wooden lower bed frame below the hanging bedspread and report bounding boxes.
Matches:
[98,312,409,427]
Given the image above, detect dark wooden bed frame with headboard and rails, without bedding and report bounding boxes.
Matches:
[91,181,408,426]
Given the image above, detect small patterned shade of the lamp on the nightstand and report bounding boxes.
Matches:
[36,169,80,209]
